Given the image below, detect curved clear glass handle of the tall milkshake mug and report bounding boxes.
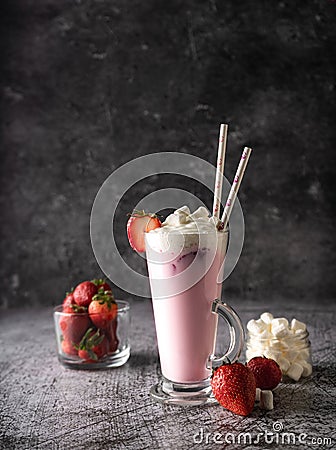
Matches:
[209,299,244,369]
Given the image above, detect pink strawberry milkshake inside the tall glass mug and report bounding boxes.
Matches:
[146,227,228,383]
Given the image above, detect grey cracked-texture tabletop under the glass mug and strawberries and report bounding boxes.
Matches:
[0,300,336,450]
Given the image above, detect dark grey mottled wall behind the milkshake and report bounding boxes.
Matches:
[0,0,336,308]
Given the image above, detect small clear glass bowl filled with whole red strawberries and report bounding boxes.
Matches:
[54,278,130,369]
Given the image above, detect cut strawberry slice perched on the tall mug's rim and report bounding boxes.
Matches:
[127,210,162,252]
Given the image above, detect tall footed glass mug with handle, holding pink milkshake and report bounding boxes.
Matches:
[145,229,244,405]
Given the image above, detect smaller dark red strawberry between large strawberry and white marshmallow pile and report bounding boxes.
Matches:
[247,356,282,390]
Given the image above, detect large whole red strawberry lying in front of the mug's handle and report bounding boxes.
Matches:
[211,363,256,416]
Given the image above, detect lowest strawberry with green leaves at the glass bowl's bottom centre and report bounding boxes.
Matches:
[78,328,109,362]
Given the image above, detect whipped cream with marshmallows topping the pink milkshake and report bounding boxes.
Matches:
[146,206,222,252]
